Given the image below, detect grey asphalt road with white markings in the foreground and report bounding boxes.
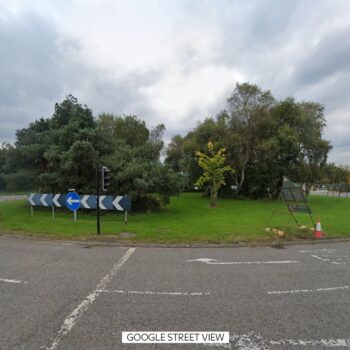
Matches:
[0,236,350,350]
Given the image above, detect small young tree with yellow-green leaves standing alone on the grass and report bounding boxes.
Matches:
[195,142,234,207]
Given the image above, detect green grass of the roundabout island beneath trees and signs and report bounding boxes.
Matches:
[0,193,350,243]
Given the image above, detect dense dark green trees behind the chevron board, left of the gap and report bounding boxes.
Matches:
[0,95,183,211]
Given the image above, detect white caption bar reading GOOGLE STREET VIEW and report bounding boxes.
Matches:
[122,332,230,344]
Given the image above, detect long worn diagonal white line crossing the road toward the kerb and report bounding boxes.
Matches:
[45,248,136,350]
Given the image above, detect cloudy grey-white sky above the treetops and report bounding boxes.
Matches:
[0,0,350,164]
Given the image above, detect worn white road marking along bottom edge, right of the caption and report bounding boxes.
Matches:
[203,332,350,350]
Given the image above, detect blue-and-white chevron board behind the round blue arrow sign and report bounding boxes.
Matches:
[28,193,131,211]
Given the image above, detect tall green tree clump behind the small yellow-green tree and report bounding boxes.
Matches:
[165,83,331,198]
